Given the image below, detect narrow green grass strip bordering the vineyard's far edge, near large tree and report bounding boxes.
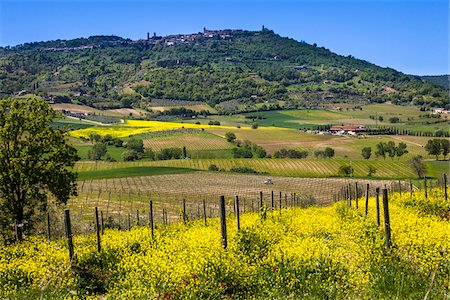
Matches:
[78,166,196,180]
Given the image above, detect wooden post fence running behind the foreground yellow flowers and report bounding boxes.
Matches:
[5,174,448,258]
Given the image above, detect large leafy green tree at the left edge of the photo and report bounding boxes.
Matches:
[0,99,78,240]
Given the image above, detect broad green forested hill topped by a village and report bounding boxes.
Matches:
[0,29,449,112]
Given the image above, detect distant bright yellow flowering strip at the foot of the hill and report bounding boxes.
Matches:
[70,120,288,138]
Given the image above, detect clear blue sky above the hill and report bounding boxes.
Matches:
[0,0,450,75]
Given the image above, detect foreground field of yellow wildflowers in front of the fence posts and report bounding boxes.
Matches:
[0,189,450,299]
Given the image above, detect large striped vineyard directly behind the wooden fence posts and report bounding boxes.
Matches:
[62,172,398,231]
